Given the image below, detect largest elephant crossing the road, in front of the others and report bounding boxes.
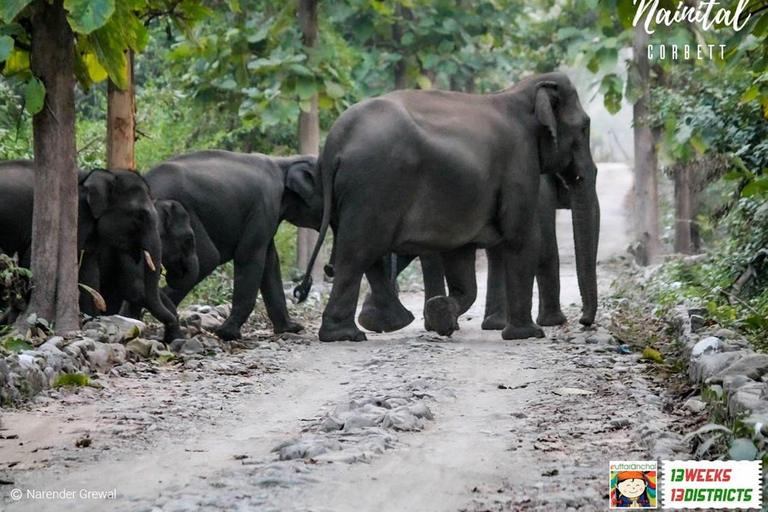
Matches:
[296,73,599,341]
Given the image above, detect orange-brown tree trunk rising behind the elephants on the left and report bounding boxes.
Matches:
[107,50,136,169]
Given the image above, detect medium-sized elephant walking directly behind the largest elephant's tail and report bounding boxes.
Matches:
[146,151,323,340]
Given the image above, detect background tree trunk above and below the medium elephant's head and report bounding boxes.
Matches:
[296,0,323,281]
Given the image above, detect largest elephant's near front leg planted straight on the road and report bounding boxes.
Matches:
[501,208,544,340]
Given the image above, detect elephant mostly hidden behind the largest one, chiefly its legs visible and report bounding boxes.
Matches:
[357,174,571,336]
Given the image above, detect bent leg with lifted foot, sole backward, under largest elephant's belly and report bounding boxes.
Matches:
[424,245,477,336]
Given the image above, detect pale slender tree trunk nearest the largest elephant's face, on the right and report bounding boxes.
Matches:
[633,24,661,265]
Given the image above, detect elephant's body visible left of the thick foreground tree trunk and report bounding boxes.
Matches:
[0,160,35,254]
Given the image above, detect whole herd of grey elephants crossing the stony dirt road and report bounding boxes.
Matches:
[0,73,600,342]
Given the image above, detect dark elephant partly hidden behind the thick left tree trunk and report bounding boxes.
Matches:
[0,160,181,340]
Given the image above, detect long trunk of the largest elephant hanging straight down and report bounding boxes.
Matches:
[570,179,600,325]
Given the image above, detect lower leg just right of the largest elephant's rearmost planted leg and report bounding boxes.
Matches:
[357,255,413,332]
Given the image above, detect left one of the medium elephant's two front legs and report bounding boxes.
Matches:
[216,242,269,341]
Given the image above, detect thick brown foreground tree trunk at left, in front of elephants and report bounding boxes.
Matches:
[22,0,80,332]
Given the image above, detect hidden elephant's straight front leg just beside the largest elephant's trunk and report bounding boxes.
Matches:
[536,175,568,326]
